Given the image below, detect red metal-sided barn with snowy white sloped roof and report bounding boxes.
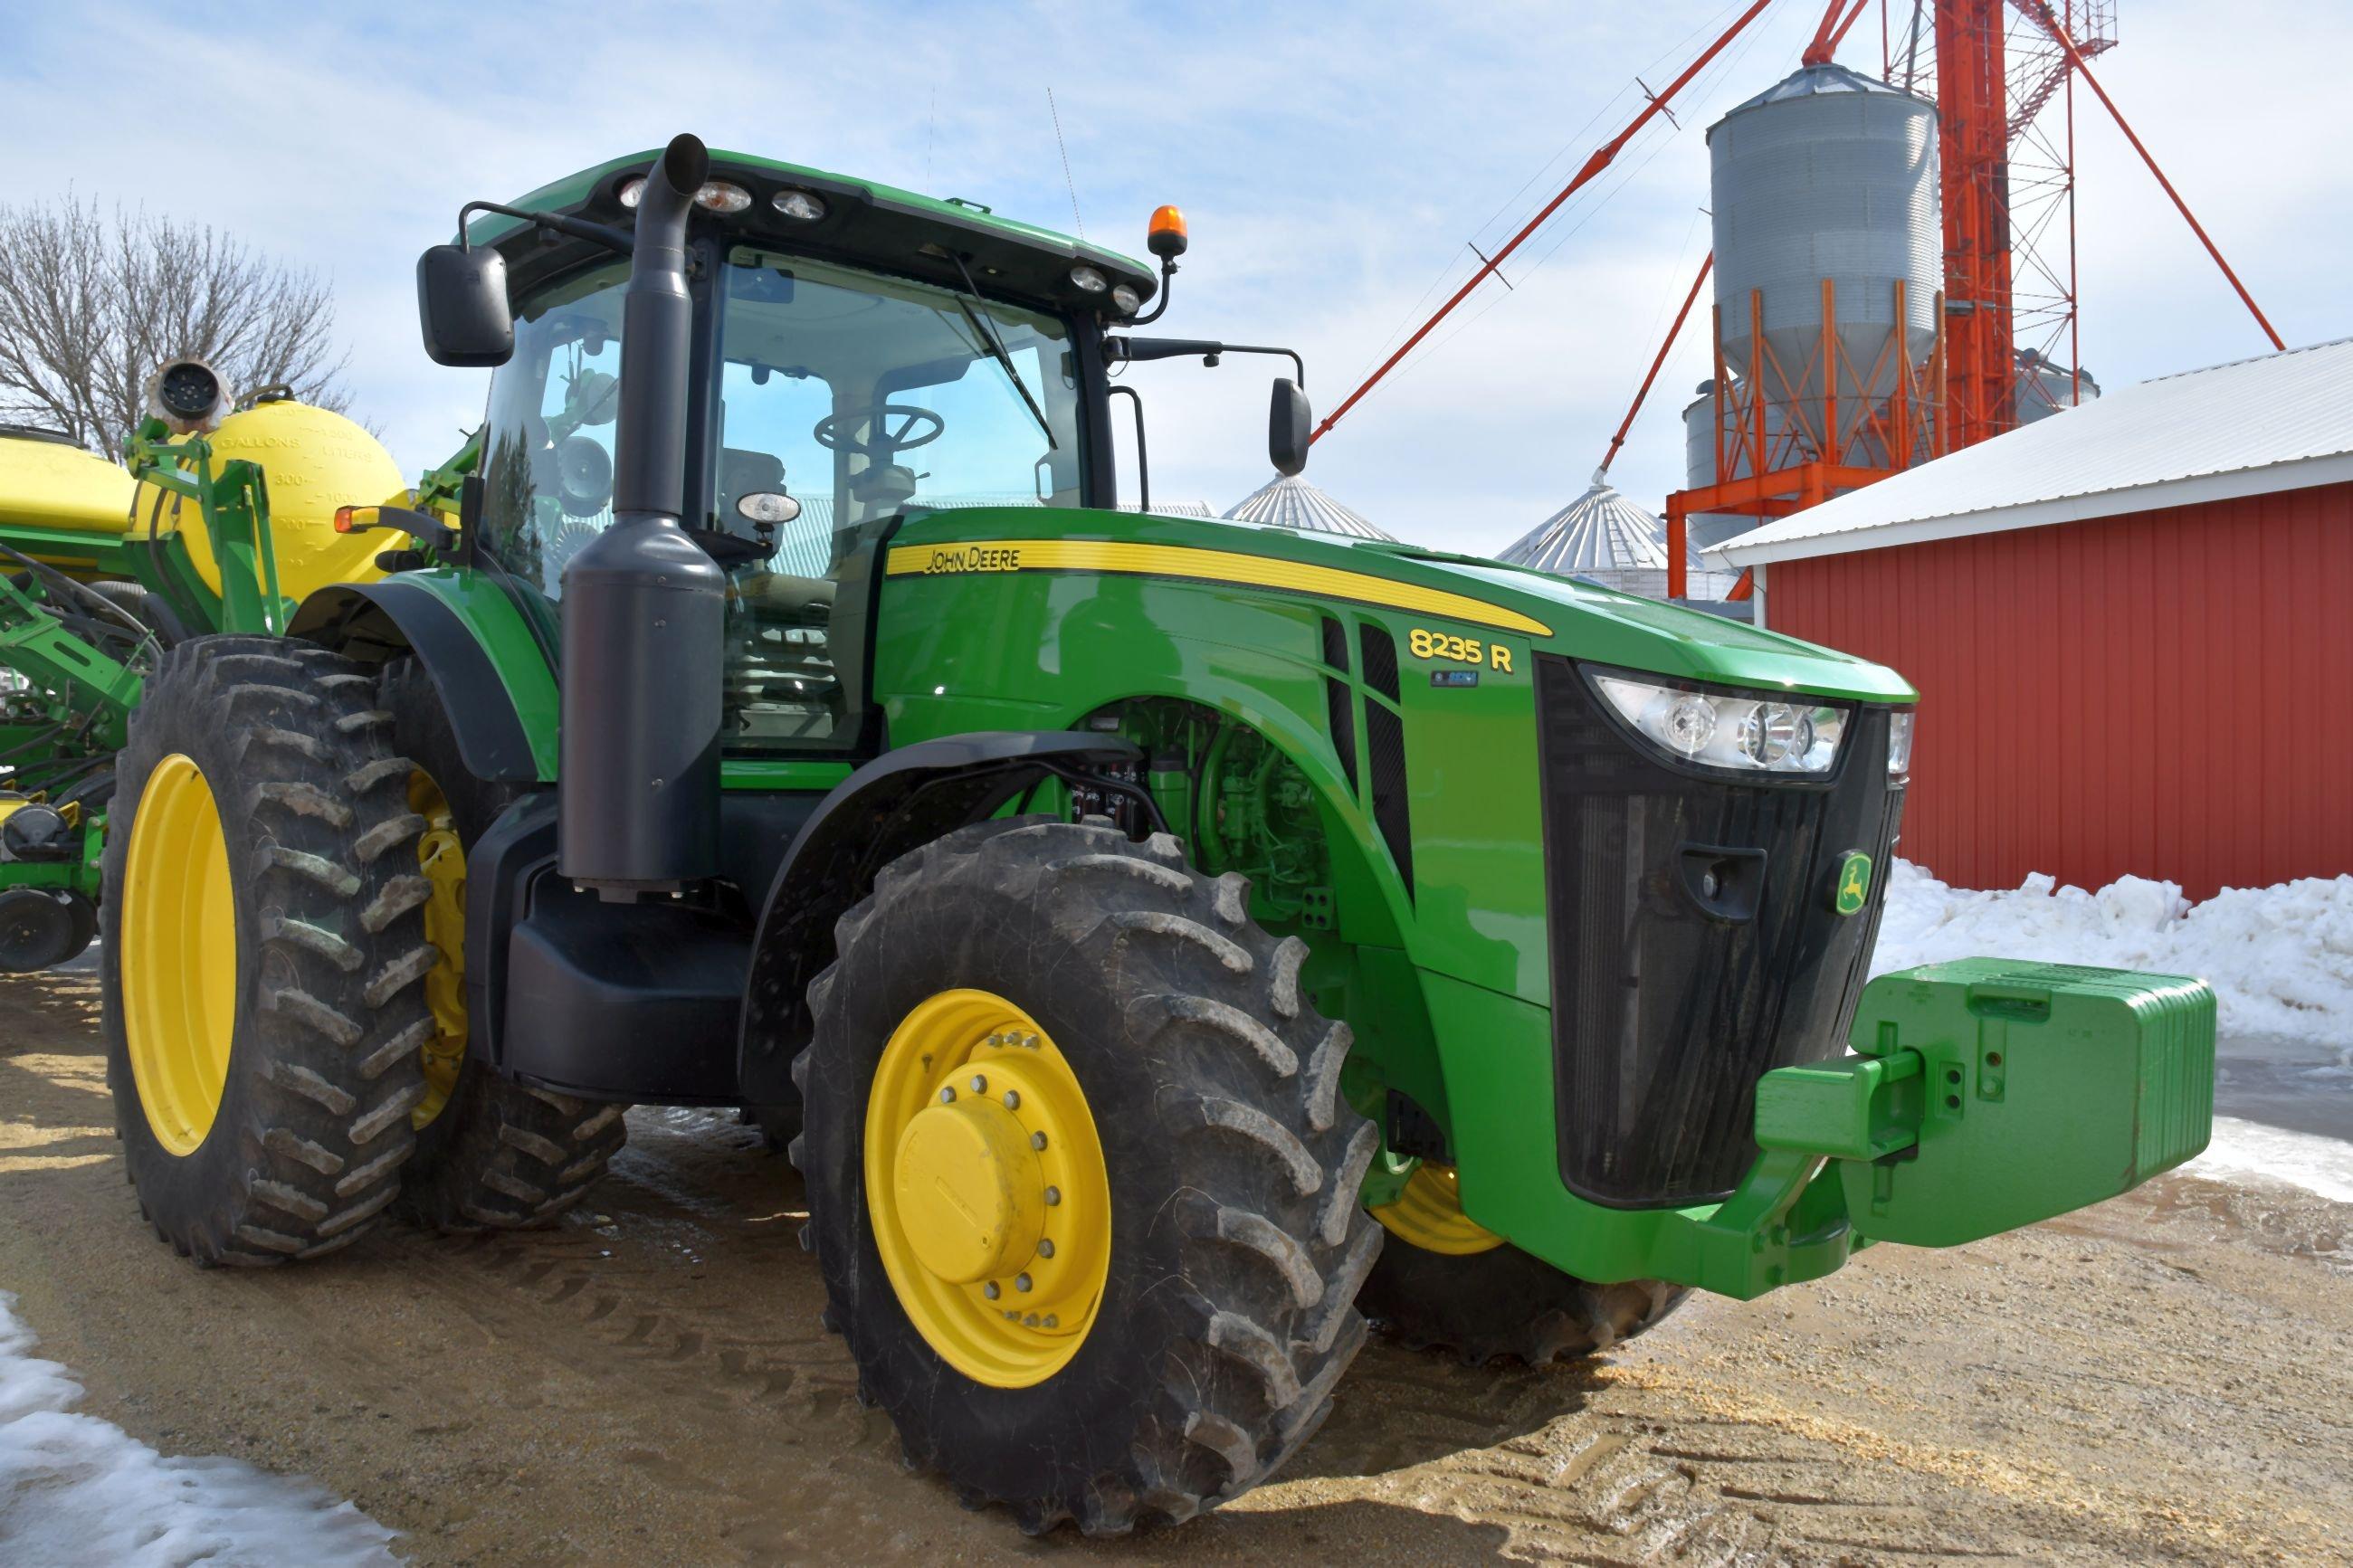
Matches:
[1720,338,2353,898]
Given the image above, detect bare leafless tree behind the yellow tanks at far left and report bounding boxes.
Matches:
[0,197,350,456]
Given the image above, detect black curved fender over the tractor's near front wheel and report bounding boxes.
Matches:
[738,731,1144,1105]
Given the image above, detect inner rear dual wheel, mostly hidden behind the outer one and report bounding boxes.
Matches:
[384,658,628,1231]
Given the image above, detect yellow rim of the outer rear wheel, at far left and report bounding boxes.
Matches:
[115,752,238,1156]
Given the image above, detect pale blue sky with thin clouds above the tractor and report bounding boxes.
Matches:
[0,0,2353,550]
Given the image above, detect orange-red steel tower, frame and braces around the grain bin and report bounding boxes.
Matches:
[1310,0,2282,600]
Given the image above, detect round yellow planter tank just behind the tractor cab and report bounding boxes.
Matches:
[132,400,407,602]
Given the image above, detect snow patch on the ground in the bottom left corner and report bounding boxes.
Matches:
[0,1290,397,1568]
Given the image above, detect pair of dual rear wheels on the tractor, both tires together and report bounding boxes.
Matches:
[101,637,621,1265]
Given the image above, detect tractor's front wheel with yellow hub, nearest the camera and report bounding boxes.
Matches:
[793,818,1381,1535]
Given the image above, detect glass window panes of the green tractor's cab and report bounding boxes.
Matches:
[482,247,1085,757]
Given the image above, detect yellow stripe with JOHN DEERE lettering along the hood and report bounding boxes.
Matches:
[887,538,1553,637]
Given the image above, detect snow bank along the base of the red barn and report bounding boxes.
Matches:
[1871,860,2353,1046]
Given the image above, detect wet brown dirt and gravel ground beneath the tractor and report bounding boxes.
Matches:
[14,974,2353,1565]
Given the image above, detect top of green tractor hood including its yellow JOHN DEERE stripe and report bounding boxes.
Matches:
[887,508,1918,703]
